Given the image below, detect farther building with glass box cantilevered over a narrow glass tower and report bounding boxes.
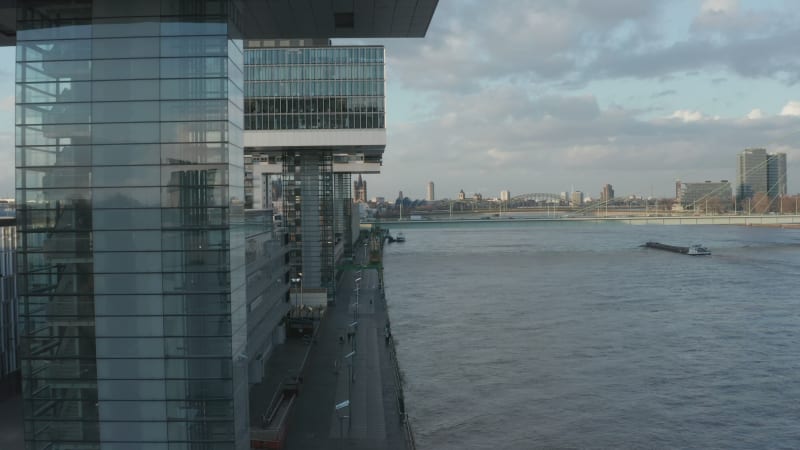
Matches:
[245,40,386,300]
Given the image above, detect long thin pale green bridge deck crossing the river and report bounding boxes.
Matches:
[363,214,800,226]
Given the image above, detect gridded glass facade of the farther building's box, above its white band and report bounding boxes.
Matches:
[245,46,386,130]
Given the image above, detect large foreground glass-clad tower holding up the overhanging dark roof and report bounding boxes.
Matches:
[16,0,249,450]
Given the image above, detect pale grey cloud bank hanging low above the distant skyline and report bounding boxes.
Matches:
[370,93,800,198]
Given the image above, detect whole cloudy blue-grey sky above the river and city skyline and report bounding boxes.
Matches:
[0,0,800,199]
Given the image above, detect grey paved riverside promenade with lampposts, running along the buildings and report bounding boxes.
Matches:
[285,246,406,450]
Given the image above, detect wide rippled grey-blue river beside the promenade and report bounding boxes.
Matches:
[385,222,800,449]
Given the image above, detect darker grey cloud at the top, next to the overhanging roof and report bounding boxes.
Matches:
[386,0,662,93]
